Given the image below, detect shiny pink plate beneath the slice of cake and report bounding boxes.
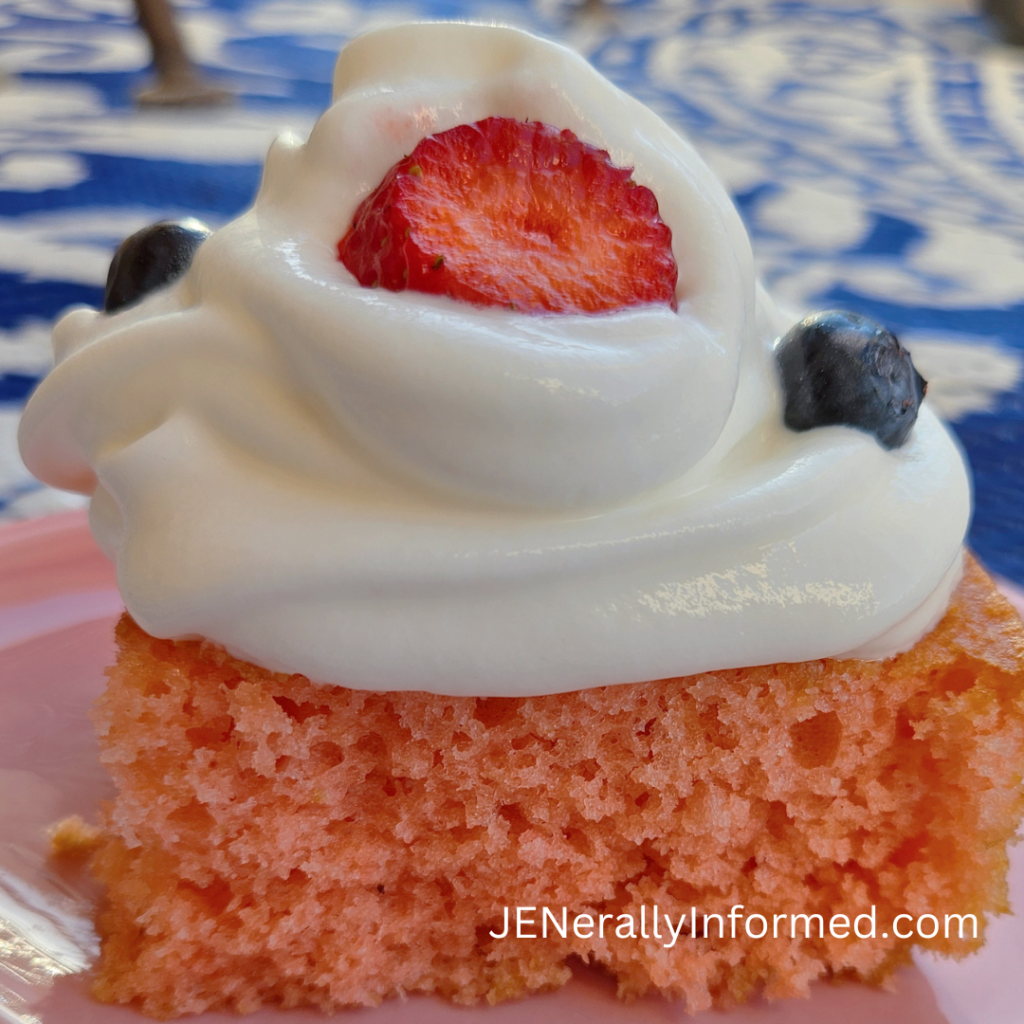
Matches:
[0,512,1024,1024]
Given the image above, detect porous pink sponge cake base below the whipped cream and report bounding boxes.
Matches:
[94,563,1024,1018]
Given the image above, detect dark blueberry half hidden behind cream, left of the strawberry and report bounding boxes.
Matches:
[103,223,210,313]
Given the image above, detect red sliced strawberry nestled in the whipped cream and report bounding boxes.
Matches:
[338,118,678,313]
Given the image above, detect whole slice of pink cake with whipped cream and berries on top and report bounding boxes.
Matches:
[22,25,1024,1018]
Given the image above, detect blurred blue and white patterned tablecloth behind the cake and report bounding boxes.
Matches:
[0,0,1024,584]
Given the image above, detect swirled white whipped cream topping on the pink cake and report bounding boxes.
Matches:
[20,24,971,695]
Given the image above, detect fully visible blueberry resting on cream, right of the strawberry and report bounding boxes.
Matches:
[778,309,928,449]
